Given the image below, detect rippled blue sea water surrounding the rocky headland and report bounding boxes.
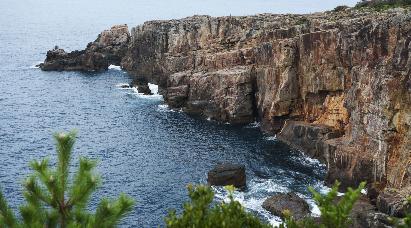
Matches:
[0,0,344,227]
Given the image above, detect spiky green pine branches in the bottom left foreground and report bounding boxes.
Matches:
[0,131,134,228]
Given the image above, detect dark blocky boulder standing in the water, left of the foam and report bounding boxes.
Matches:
[207,163,246,189]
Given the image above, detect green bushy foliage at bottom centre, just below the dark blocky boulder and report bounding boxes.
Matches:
[165,185,270,228]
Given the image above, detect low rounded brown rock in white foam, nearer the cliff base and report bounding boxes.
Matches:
[263,192,310,220]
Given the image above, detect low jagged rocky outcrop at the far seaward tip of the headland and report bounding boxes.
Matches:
[39,25,130,71]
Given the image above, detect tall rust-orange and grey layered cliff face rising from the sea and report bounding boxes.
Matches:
[40,9,411,214]
